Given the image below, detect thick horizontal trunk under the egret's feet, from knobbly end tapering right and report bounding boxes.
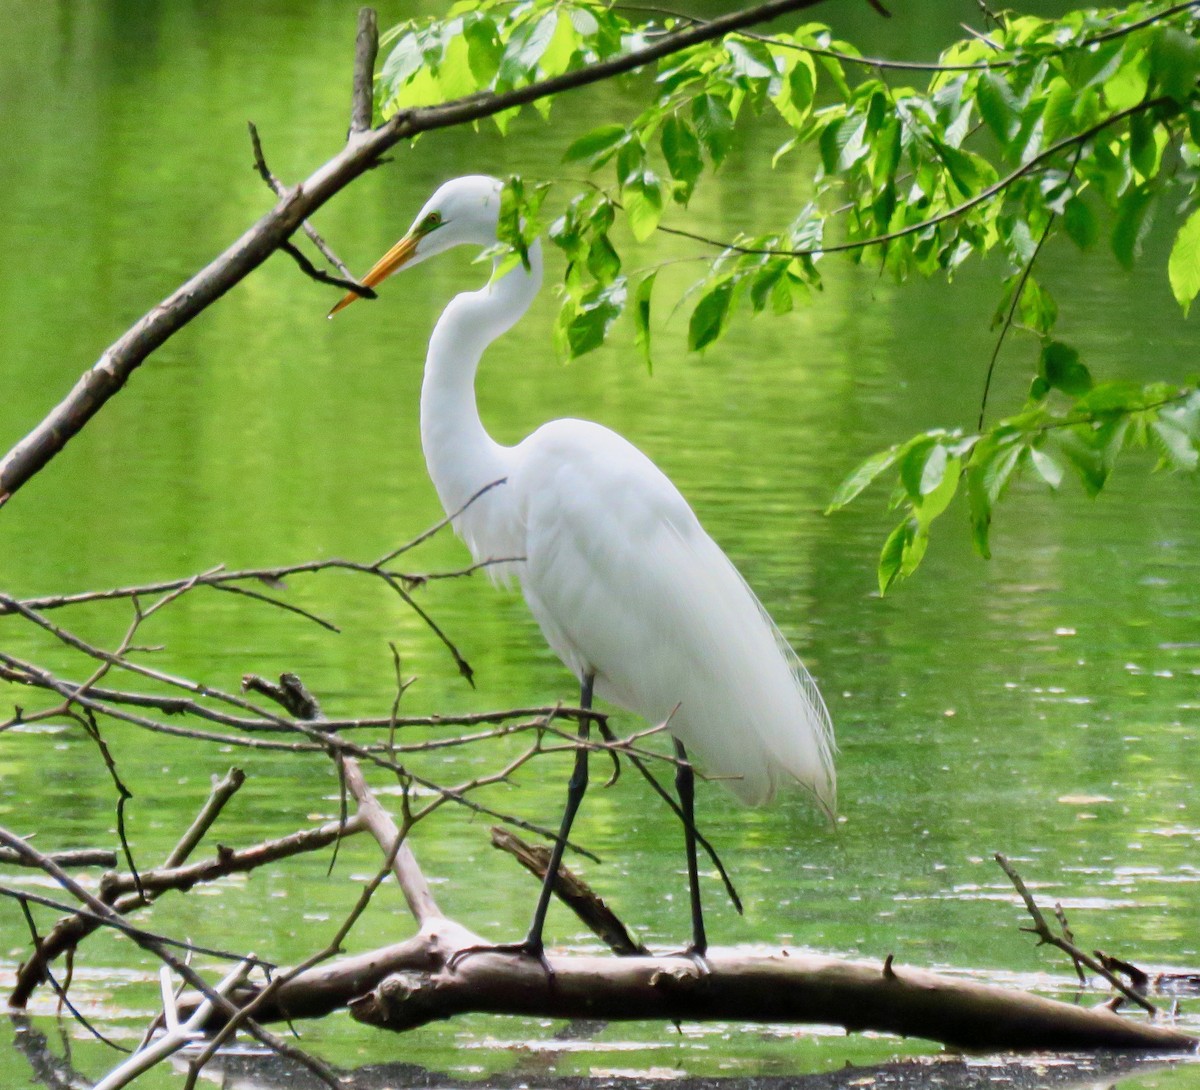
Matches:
[340,951,1200,1052]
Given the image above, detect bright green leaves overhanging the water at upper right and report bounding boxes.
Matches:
[378,0,1200,589]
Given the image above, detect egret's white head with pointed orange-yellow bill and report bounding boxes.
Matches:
[329,174,503,318]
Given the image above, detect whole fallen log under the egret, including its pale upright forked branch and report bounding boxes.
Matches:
[164,759,1200,1053]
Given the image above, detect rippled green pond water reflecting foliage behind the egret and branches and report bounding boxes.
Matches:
[0,0,1200,1086]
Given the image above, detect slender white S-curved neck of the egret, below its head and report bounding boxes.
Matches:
[421,241,541,514]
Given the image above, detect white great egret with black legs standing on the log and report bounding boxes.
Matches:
[330,175,834,960]
